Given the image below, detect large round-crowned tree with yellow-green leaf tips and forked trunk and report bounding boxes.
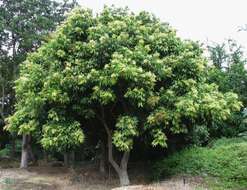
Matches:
[7,7,241,185]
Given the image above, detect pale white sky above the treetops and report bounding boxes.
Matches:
[79,0,247,50]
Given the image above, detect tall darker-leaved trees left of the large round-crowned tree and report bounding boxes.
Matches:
[0,0,76,155]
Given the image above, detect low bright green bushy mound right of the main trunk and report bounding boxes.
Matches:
[153,138,247,189]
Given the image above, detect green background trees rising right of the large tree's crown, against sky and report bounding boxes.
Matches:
[208,39,247,107]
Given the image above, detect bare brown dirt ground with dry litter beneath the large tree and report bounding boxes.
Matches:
[0,163,206,190]
